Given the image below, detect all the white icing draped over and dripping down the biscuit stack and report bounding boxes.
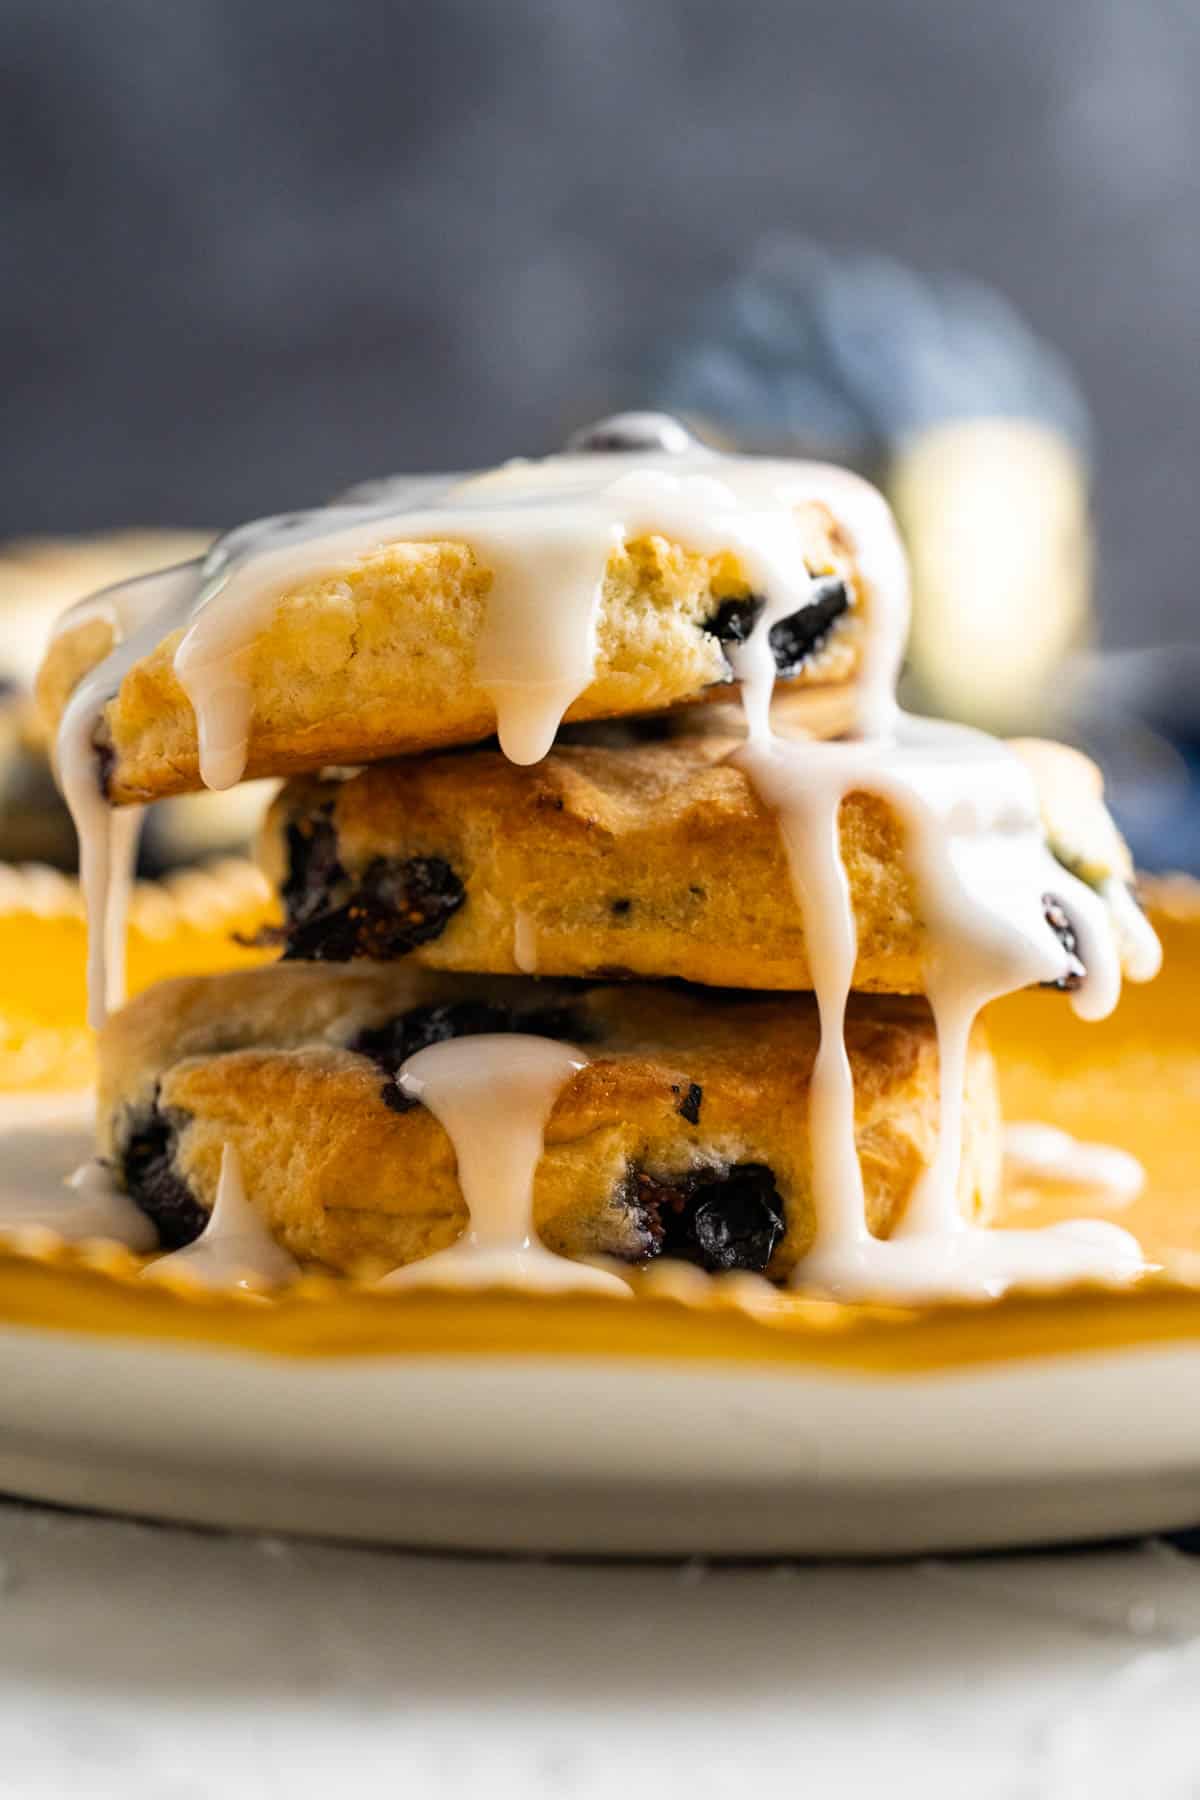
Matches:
[49,424,1157,1298]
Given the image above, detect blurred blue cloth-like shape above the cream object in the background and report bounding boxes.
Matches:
[644,234,1092,466]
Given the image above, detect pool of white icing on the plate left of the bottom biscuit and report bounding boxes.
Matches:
[0,1093,158,1251]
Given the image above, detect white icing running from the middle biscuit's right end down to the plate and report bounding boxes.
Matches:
[732,493,1157,1300]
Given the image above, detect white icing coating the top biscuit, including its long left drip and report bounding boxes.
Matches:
[59,450,863,1022]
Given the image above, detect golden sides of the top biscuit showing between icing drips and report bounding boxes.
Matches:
[38,502,871,803]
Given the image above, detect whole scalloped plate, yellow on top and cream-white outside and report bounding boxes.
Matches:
[0,884,1200,1557]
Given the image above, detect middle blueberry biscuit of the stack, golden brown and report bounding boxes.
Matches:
[259,736,1144,994]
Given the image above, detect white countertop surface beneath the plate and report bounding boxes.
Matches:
[0,1503,1200,1800]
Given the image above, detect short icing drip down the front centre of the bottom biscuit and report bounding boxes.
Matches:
[383,1031,630,1294]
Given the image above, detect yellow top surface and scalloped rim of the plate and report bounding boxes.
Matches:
[0,880,1200,1375]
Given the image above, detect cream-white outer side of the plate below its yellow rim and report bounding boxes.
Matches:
[0,1318,1200,1557]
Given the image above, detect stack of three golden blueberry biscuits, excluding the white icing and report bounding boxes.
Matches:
[41,417,1128,1282]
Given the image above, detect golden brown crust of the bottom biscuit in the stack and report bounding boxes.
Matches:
[99,965,1000,1278]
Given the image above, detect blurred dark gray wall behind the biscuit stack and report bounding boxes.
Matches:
[0,0,1200,644]
